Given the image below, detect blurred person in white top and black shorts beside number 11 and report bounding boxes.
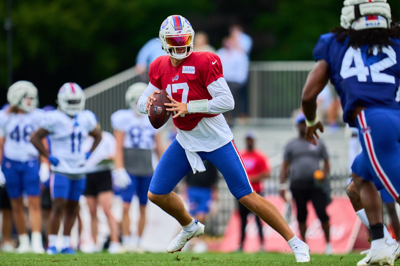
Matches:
[83,124,121,254]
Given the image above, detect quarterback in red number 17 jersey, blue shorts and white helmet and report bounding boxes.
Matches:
[137,15,310,262]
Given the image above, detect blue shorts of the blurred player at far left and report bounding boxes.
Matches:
[2,157,40,199]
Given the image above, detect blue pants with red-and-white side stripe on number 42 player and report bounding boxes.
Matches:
[352,108,400,200]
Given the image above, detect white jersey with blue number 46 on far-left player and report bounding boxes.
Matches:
[0,109,44,162]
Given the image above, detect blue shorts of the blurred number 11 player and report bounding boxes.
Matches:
[50,173,86,201]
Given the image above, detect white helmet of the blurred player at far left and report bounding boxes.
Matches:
[7,80,39,113]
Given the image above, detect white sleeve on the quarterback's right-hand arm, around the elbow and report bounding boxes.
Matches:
[199,78,235,114]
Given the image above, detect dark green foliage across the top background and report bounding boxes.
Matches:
[0,0,400,104]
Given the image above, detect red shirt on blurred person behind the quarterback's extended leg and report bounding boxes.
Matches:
[240,150,271,193]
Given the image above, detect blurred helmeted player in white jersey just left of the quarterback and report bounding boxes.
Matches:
[111,82,163,251]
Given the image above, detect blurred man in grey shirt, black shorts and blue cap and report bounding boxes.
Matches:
[280,113,332,254]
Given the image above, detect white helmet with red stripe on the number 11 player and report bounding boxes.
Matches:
[57,82,86,116]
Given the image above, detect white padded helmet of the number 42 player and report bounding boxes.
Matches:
[340,0,392,30]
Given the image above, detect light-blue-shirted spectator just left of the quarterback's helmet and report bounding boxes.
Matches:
[135,38,166,75]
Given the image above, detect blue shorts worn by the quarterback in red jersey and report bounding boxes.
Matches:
[150,139,253,199]
